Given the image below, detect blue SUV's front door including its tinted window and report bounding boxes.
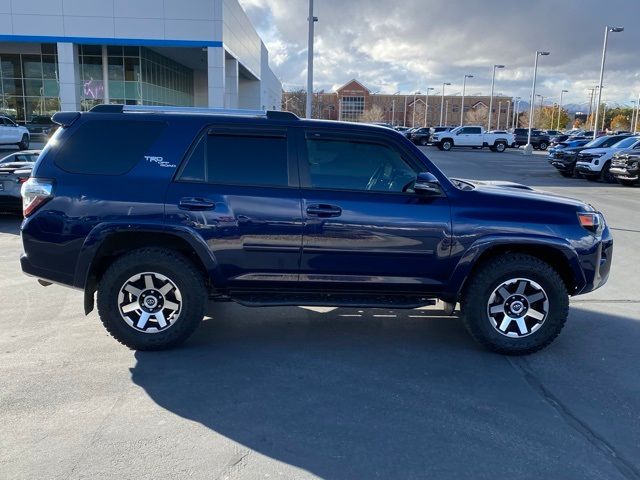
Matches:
[299,130,451,292]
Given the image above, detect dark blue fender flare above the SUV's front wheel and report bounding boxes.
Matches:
[447,235,587,296]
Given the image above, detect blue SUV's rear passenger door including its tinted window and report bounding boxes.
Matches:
[166,125,302,288]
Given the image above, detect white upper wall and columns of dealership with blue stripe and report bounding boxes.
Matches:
[0,0,282,112]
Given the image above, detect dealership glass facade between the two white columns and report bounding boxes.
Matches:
[79,45,194,110]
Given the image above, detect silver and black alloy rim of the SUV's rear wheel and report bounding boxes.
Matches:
[118,272,182,333]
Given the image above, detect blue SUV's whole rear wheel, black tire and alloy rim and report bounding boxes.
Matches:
[98,248,207,350]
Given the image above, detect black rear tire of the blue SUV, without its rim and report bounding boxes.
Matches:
[97,248,207,350]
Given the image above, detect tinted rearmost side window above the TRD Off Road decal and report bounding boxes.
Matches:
[55,120,166,175]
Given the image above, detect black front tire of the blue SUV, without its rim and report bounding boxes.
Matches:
[461,253,569,355]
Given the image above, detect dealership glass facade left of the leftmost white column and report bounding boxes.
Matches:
[0,43,60,122]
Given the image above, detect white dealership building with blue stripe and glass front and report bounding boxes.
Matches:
[0,0,282,122]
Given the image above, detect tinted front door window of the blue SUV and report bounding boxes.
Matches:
[306,137,417,192]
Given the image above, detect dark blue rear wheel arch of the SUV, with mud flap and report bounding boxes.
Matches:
[74,225,220,314]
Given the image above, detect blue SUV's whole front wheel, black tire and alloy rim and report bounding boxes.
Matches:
[461,254,569,355]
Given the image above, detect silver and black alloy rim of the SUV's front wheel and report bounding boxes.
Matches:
[487,278,549,338]
